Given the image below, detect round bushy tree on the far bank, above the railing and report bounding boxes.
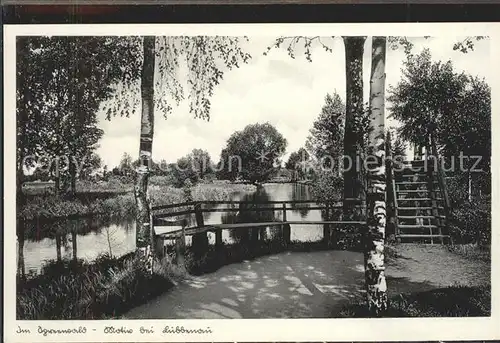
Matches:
[218,123,287,182]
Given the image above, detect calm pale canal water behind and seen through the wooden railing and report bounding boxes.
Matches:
[16,183,323,273]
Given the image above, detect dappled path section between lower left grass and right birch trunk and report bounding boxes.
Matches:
[124,251,364,319]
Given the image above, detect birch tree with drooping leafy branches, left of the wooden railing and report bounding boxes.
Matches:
[105,36,251,274]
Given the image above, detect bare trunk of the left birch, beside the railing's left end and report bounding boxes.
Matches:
[134,36,155,274]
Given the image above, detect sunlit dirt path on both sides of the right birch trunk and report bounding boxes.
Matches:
[124,247,489,319]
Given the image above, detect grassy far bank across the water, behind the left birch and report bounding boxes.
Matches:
[18,177,255,220]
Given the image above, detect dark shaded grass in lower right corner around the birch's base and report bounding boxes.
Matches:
[333,286,491,318]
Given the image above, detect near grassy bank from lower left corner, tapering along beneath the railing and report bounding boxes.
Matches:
[17,240,334,320]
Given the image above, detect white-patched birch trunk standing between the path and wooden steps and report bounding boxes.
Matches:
[364,37,387,316]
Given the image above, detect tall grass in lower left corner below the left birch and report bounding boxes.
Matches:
[17,256,185,320]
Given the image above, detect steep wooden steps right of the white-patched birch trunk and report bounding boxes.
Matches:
[392,160,449,244]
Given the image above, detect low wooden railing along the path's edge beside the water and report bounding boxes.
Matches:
[151,199,366,260]
